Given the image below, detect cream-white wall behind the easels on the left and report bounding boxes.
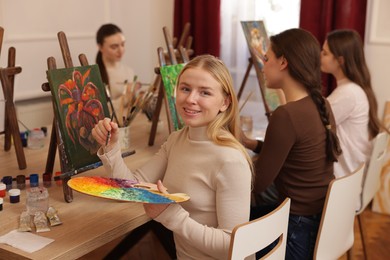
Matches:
[0,0,173,130]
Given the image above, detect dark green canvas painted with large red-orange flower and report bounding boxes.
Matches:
[47,65,109,170]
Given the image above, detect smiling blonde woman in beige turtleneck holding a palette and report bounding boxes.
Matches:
[93,55,252,259]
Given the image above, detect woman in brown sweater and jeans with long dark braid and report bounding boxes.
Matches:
[245,29,341,259]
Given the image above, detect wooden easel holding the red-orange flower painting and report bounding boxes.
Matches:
[42,32,99,202]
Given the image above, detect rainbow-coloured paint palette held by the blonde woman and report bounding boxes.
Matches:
[68,176,190,204]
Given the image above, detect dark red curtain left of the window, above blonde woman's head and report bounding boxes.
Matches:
[173,0,221,57]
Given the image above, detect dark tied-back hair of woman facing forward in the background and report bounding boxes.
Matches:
[96,23,122,85]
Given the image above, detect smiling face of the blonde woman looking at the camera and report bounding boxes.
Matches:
[176,68,230,127]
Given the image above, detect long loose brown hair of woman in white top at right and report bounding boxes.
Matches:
[327,30,381,138]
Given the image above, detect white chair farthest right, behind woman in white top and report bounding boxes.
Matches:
[356,132,389,259]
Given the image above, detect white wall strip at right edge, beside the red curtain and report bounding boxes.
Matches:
[365,0,390,119]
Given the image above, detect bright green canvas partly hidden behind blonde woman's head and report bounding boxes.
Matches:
[160,64,185,131]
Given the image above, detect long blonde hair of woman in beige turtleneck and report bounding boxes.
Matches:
[177,55,253,173]
